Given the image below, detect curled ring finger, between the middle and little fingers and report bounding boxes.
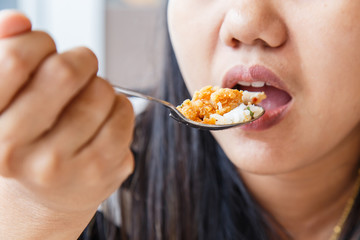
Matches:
[38,77,115,159]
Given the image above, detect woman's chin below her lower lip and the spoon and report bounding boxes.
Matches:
[212,109,306,175]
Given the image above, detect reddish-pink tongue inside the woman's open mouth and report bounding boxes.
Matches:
[241,86,291,110]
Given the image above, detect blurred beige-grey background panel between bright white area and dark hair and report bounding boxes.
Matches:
[106,3,164,89]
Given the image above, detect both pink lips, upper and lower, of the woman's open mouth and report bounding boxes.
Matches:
[222,65,293,131]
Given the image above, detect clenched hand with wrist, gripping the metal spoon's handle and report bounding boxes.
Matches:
[0,12,134,239]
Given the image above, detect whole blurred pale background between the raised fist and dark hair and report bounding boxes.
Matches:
[0,0,164,88]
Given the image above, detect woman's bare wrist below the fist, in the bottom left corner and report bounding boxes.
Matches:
[0,177,96,240]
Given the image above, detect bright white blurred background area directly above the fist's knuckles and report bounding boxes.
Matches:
[18,0,106,75]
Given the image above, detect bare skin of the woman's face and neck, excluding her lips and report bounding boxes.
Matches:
[168,0,360,239]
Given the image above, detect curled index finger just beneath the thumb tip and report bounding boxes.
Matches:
[0,32,56,112]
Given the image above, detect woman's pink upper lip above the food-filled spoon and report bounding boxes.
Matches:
[222,65,288,92]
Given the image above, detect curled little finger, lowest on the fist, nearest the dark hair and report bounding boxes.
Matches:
[77,96,134,184]
